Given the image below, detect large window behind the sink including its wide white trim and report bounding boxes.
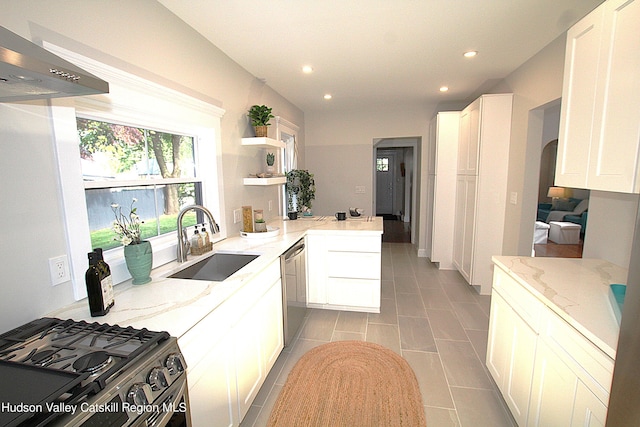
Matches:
[43,41,226,300]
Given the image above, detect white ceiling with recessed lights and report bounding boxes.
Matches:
[158,0,602,112]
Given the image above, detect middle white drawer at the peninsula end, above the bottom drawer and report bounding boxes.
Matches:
[327,251,380,279]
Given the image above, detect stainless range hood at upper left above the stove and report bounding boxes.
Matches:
[0,27,109,102]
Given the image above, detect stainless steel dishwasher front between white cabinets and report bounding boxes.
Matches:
[280,239,307,347]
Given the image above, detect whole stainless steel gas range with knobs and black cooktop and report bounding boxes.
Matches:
[0,318,191,427]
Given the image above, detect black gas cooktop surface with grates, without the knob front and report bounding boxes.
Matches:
[0,318,170,426]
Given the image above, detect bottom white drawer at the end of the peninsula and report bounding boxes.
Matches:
[327,278,380,308]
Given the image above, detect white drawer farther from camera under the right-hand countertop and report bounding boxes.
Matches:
[493,266,546,332]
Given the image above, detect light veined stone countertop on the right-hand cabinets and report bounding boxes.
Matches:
[492,256,627,360]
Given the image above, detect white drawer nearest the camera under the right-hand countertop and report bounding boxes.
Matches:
[541,310,614,402]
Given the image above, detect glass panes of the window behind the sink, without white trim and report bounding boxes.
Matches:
[76,117,202,250]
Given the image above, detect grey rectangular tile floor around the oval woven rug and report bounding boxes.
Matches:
[242,243,515,427]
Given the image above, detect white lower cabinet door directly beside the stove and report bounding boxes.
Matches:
[188,335,239,427]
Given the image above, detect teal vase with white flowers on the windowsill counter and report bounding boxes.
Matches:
[111,197,153,285]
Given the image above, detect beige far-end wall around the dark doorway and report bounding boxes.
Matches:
[305,105,435,246]
